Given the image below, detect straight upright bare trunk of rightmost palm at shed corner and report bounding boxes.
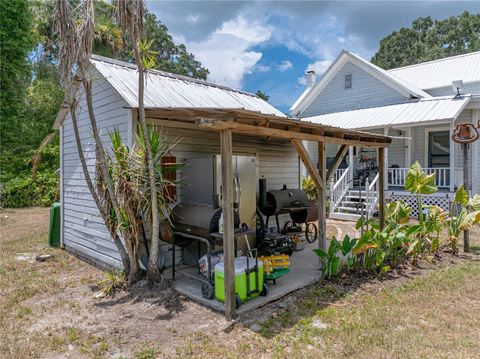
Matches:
[132,33,162,284]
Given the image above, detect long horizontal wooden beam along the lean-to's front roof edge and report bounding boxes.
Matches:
[196,118,388,147]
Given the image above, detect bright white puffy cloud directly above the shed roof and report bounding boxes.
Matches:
[182,15,272,88]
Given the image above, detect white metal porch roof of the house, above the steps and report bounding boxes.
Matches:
[302,96,471,129]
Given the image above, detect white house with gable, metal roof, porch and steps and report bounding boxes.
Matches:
[290,50,480,219]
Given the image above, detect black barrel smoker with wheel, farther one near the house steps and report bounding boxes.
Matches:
[259,179,318,243]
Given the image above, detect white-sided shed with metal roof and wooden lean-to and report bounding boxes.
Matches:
[55,56,391,318]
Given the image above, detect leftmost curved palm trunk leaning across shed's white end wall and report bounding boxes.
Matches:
[70,100,131,277]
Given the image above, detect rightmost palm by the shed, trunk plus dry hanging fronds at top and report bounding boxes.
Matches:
[114,0,162,284]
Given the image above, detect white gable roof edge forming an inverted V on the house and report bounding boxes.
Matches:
[290,50,431,116]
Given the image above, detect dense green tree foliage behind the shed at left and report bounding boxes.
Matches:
[0,0,208,206]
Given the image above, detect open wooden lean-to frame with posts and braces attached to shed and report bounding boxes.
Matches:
[145,107,391,319]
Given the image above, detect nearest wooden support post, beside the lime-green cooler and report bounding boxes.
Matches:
[220,130,236,320]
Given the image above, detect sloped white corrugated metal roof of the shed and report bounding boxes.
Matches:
[91,55,286,117]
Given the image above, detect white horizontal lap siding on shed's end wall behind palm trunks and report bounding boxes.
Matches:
[62,79,130,268]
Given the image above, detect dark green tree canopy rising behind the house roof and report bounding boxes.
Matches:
[371,11,480,70]
